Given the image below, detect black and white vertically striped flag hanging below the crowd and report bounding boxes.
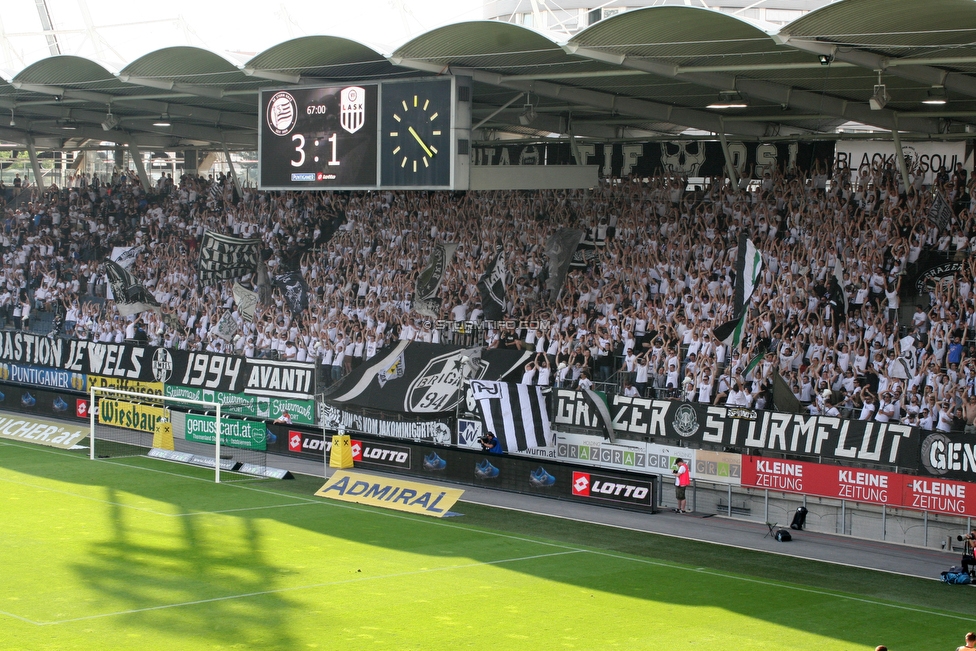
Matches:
[471,380,552,452]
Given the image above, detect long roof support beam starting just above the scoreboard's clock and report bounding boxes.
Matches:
[390,56,766,136]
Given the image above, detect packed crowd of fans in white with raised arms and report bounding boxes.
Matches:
[0,158,976,430]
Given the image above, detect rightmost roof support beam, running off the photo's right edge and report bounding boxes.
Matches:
[773,32,976,99]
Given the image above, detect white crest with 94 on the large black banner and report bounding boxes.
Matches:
[403,350,488,414]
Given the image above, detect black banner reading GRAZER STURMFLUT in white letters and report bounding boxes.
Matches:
[553,390,920,468]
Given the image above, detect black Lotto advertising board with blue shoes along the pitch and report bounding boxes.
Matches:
[268,425,656,512]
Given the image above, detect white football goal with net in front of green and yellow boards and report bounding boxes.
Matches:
[88,387,268,483]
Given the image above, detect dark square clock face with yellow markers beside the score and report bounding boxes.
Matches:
[380,79,452,187]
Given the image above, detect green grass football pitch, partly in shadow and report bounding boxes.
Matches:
[0,442,976,651]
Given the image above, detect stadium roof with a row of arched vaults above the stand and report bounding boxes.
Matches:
[0,0,976,150]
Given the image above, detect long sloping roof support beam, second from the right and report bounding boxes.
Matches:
[563,44,939,133]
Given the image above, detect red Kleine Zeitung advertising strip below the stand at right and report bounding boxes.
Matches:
[742,456,976,516]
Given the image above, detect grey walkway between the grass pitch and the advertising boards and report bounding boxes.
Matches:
[269,457,961,580]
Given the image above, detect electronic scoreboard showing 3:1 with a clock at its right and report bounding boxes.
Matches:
[258,76,471,190]
